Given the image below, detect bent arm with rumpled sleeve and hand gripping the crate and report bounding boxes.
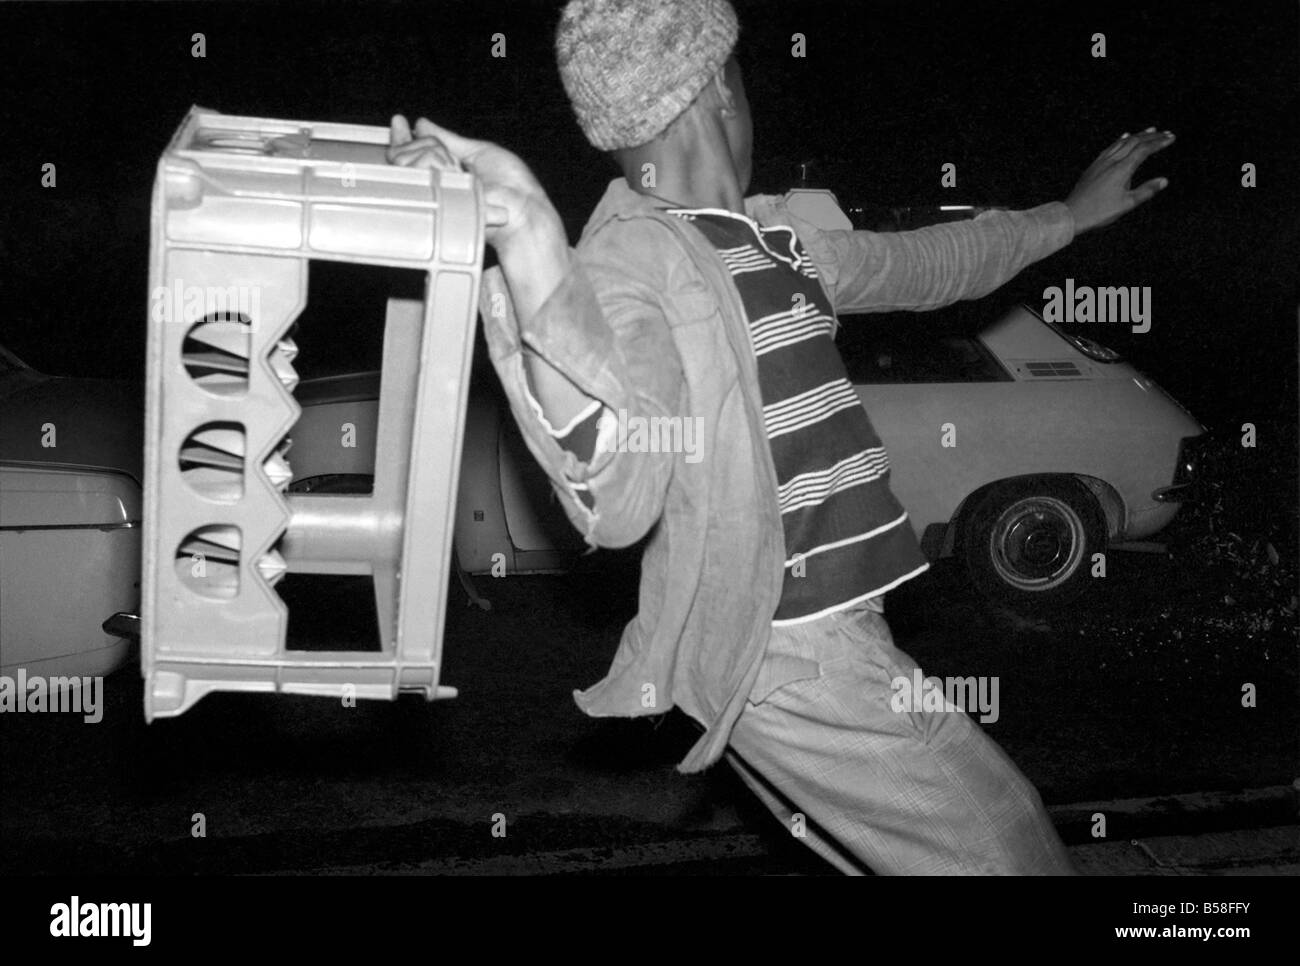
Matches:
[389,117,684,547]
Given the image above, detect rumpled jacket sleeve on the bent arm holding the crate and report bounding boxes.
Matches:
[480,221,685,547]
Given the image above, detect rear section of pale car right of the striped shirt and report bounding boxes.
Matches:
[839,304,1204,606]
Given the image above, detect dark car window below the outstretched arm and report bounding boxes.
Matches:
[836,309,1011,385]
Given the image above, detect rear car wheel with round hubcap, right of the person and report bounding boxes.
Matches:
[961,477,1106,612]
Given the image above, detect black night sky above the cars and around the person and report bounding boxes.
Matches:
[0,1,1300,434]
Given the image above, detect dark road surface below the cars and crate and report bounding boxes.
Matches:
[0,555,1300,874]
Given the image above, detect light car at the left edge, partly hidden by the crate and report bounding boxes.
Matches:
[0,347,143,677]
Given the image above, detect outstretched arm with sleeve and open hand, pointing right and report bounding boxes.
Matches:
[809,129,1174,312]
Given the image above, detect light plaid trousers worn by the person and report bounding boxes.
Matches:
[727,605,1074,875]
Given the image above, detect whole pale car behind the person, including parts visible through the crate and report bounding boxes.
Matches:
[291,295,1203,607]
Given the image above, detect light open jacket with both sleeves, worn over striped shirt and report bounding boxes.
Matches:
[481,178,1074,772]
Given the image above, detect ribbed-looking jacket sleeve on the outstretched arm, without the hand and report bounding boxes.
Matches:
[789,202,1074,312]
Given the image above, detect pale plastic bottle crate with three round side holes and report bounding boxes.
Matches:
[140,108,485,720]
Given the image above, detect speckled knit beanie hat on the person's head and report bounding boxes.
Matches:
[555,0,738,151]
